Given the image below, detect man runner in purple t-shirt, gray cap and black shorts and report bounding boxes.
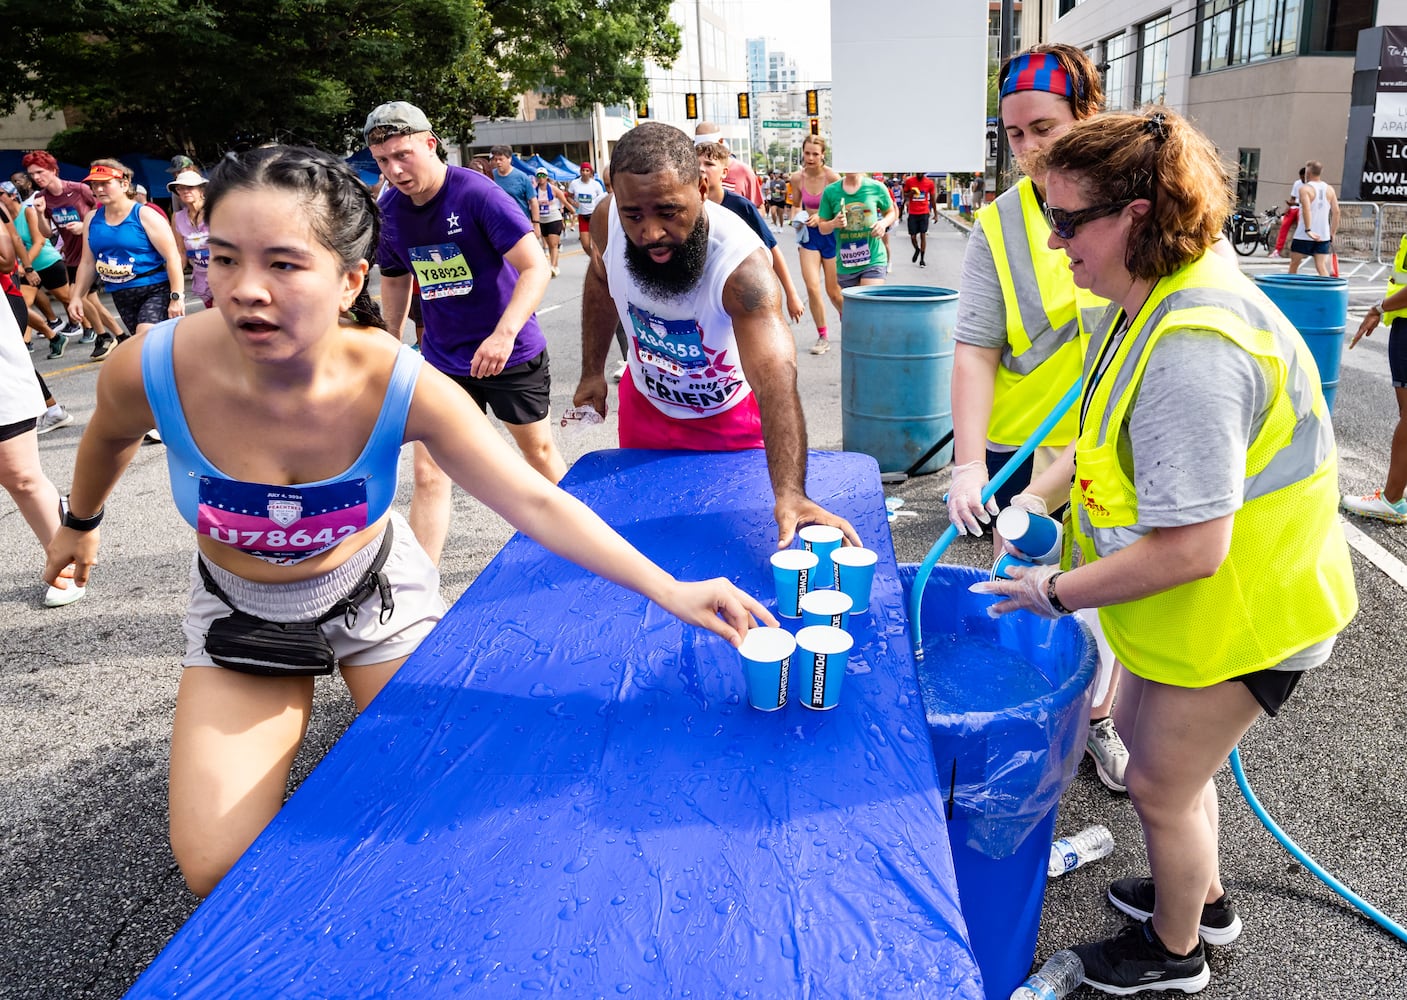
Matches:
[363,101,567,563]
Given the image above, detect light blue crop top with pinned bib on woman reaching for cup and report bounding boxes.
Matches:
[142,319,421,565]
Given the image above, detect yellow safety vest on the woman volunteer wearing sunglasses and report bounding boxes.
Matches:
[1071,253,1358,686]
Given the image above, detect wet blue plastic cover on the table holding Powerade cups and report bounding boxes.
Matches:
[128,450,982,1000]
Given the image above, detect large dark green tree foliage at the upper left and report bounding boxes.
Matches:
[0,0,678,162]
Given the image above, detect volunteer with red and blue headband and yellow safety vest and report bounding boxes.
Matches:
[948,45,1128,792]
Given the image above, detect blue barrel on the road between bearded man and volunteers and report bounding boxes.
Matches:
[840,284,958,474]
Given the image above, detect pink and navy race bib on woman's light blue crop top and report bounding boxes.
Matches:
[196,475,367,565]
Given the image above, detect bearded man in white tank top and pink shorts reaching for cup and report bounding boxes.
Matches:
[574,122,860,549]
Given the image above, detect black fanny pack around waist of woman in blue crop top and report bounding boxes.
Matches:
[196,522,395,677]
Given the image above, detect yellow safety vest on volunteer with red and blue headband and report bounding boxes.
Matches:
[976,177,1107,444]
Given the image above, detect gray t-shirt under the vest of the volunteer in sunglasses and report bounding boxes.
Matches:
[1079,329,1334,669]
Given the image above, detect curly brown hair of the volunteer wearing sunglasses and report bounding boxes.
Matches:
[1036,104,1235,278]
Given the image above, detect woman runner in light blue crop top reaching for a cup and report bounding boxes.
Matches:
[45,146,775,895]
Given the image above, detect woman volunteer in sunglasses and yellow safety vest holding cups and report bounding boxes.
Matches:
[974,108,1358,994]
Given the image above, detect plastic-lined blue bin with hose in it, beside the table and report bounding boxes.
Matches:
[899,565,1099,997]
